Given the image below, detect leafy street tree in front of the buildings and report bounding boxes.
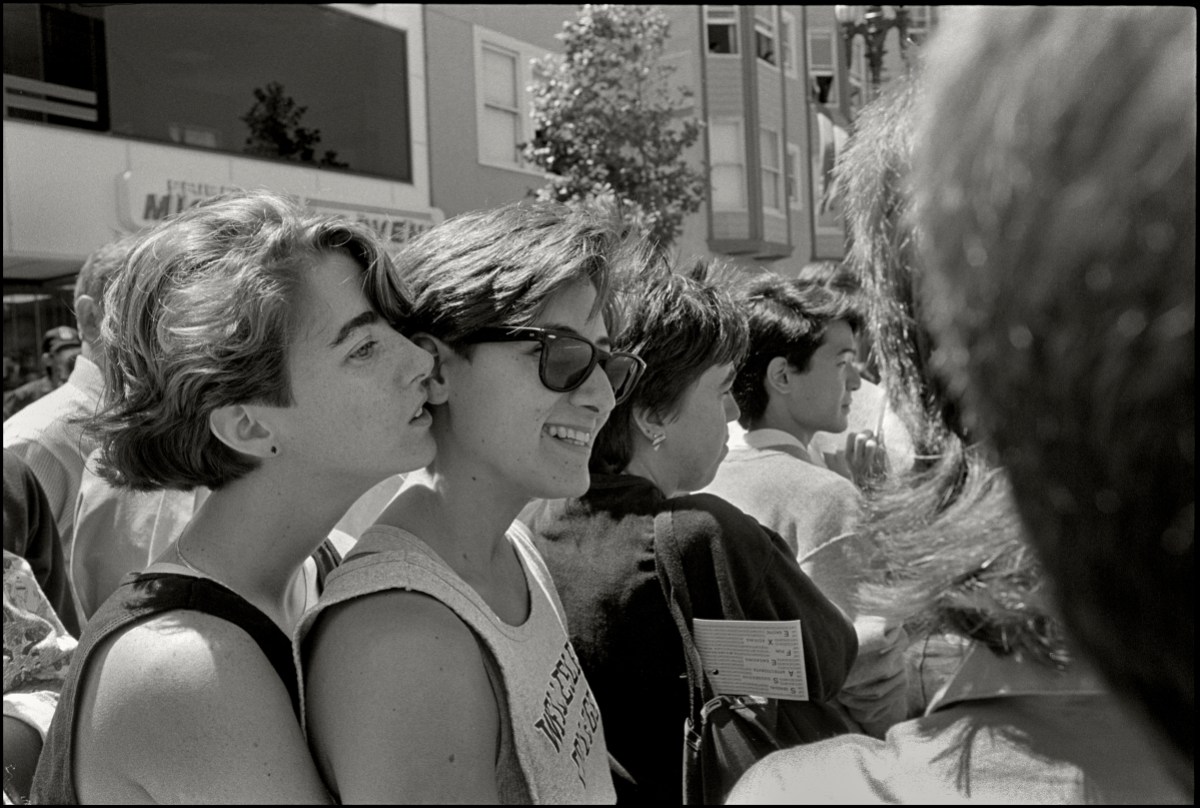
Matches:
[522,5,707,252]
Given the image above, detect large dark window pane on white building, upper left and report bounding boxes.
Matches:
[5,4,412,181]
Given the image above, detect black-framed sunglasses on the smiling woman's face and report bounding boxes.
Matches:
[463,325,646,403]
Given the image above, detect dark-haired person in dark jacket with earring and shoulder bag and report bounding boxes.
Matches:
[530,264,857,804]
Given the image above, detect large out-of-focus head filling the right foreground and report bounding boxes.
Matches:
[914,7,1196,785]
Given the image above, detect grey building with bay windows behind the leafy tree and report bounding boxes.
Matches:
[425,4,934,275]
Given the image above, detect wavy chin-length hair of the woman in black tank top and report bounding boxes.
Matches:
[89,191,409,490]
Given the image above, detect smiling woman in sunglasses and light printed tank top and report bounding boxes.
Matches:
[296,205,643,804]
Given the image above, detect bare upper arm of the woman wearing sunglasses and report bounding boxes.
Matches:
[305,591,500,804]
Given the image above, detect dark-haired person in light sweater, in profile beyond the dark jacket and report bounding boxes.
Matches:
[703,275,908,736]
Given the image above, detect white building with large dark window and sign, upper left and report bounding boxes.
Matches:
[4,4,442,389]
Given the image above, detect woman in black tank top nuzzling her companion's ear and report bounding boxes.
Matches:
[32,191,434,804]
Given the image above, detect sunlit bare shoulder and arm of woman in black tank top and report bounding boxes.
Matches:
[76,611,329,804]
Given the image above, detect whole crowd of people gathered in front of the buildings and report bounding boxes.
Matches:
[4,7,1195,804]
